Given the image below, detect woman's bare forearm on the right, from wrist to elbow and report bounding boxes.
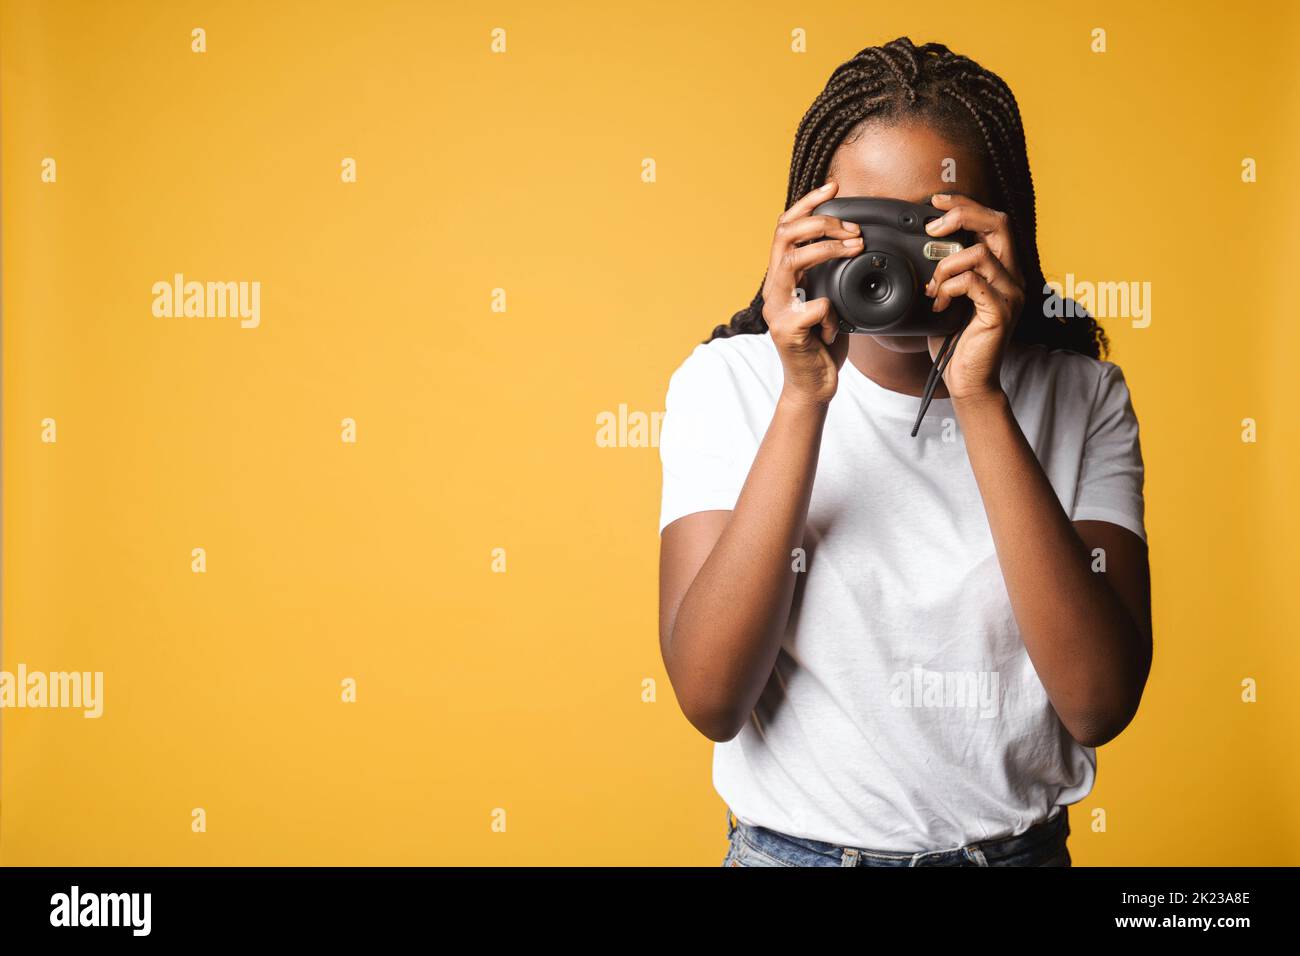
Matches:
[954,392,1147,744]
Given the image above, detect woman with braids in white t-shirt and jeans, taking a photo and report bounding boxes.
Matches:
[660,39,1152,866]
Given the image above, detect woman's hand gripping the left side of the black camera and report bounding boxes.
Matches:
[763,182,862,405]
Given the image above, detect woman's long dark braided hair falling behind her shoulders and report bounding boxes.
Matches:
[710,36,1109,359]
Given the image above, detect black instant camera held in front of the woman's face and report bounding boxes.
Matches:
[803,196,975,336]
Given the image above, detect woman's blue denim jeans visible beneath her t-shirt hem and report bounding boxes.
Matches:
[723,806,1070,866]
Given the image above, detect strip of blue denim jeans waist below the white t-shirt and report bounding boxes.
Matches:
[727,805,1070,866]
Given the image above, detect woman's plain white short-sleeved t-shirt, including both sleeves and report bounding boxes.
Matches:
[659,334,1145,852]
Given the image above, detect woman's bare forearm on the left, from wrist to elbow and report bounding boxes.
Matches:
[664,397,827,740]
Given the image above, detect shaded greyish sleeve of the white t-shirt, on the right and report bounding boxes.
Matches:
[1070,362,1147,541]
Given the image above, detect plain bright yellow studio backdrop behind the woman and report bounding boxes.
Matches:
[0,1,1300,865]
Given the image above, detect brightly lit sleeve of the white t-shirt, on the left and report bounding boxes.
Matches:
[659,345,770,532]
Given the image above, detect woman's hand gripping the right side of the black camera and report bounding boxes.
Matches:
[926,194,1024,402]
